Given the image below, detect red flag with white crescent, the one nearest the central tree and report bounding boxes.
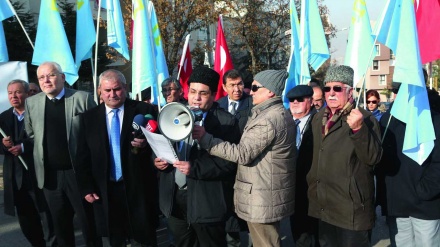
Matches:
[214,15,234,100]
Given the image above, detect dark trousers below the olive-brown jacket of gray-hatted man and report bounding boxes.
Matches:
[319,220,371,247]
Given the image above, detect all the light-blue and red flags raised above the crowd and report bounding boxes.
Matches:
[0,0,440,164]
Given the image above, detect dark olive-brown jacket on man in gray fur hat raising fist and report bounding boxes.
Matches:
[307,109,382,231]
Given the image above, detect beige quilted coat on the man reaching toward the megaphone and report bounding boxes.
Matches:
[200,97,297,223]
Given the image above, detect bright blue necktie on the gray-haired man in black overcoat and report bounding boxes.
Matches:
[110,109,122,181]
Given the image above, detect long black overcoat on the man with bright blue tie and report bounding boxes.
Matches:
[75,99,158,244]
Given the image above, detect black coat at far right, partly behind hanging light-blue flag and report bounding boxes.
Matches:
[376,105,440,220]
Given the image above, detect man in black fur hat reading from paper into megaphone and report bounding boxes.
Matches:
[154,67,240,247]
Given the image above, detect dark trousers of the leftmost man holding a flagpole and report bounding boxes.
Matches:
[14,184,56,246]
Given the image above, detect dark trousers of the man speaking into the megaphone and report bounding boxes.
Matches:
[168,188,227,247]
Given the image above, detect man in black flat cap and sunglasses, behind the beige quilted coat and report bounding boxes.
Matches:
[286,85,319,247]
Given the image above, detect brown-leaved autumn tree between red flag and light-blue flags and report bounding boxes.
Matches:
[218,0,335,81]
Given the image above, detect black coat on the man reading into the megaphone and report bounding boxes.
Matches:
[159,102,240,224]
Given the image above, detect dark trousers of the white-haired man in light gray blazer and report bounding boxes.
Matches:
[44,169,98,247]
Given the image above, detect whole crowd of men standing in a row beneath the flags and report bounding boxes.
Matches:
[0,62,440,247]
